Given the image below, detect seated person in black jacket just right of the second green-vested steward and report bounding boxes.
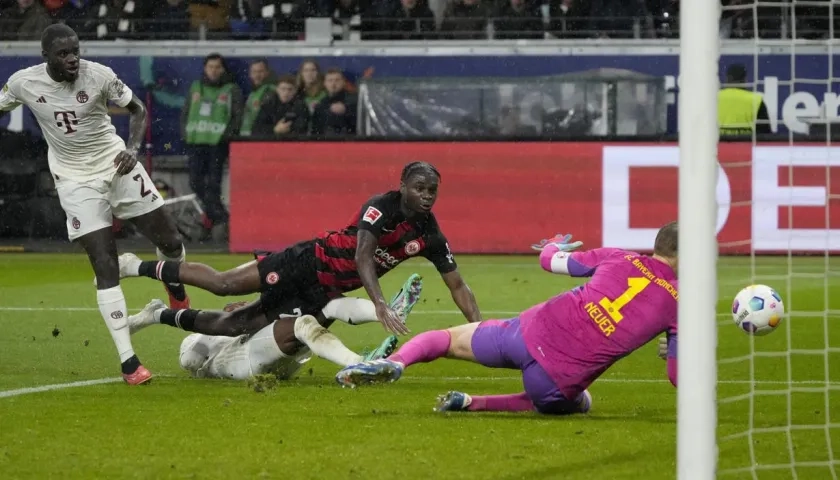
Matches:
[254,75,309,137]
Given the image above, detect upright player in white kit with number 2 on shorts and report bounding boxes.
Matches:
[0,24,189,385]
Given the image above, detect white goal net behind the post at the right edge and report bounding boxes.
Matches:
[680,0,840,480]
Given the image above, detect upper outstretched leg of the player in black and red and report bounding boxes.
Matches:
[119,253,261,297]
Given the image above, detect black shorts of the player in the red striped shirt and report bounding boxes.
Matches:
[254,240,334,319]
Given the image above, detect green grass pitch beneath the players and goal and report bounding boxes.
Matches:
[0,254,840,480]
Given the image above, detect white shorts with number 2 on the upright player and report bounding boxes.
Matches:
[53,163,164,241]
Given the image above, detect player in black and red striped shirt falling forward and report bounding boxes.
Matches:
[120,162,481,336]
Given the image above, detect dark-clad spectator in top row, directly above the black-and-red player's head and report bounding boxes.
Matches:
[362,0,435,40]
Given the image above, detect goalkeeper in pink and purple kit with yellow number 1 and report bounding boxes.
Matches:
[336,222,679,414]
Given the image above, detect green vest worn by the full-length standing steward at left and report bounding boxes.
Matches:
[187,81,234,145]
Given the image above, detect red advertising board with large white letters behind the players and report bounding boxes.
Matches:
[230,142,840,253]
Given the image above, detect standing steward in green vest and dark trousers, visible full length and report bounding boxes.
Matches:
[181,53,243,236]
